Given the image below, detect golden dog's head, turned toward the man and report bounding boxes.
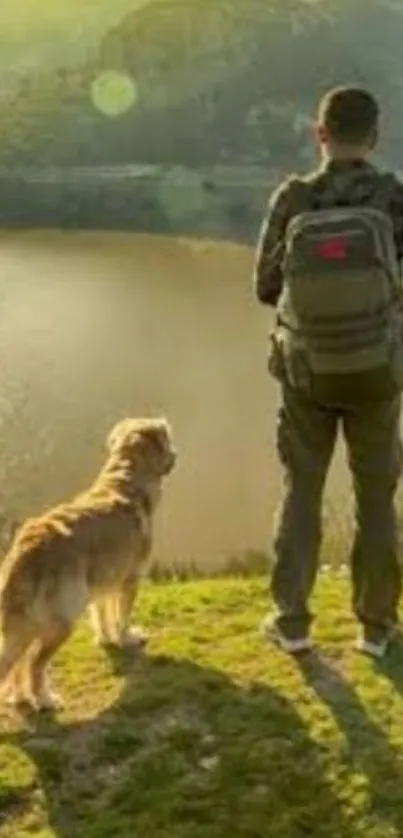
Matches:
[107,419,177,477]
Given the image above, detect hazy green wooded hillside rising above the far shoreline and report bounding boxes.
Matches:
[0,0,403,168]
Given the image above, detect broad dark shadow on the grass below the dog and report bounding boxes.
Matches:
[0,656,362,838]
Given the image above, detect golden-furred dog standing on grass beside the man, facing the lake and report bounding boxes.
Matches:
[0,419,176,708]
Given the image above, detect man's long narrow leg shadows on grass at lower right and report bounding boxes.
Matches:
[298,651,403,836]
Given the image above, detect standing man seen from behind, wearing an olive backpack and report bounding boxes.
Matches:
[254,87,403,657]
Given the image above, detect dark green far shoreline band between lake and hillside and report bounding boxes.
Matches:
[0,163,278,244]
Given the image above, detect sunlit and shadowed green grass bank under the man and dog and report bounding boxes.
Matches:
[0,573,403,838]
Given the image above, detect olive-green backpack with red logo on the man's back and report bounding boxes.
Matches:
[277,175,403,403]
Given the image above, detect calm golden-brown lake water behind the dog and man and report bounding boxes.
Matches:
[0,232,354,569]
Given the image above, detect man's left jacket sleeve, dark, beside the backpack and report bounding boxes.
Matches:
[253,181,291,306]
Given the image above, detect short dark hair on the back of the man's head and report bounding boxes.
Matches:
[318,87,379,145]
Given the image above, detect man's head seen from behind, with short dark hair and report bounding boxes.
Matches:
[316,87,379,159]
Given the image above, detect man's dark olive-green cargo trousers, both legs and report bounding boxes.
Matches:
[272,384,402,637]
